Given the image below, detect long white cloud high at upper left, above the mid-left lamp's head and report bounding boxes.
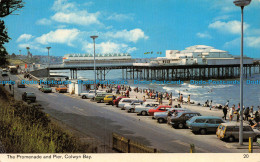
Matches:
[51,11,101,25]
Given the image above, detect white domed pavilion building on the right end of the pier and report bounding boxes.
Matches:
[151,45,253,65]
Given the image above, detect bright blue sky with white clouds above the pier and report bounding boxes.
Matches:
[2,0,260,58]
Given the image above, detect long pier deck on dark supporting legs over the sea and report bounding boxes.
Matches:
[49,62,260,80]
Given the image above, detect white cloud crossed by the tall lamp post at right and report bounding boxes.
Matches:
[209,20,249,34]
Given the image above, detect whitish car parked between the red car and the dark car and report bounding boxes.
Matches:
[153,108,189,123]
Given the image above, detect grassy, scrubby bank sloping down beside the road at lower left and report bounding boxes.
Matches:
[0,86,93,153]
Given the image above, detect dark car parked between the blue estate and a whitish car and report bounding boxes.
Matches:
[167,111,201,129]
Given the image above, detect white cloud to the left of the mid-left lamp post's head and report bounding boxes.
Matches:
[35,29,80,46]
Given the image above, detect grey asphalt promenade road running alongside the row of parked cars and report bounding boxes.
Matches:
[0,75,256,153]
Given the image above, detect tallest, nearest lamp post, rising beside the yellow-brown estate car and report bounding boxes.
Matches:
[234,0,251,145]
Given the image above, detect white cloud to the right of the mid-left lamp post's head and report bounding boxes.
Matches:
[105,28,149,43]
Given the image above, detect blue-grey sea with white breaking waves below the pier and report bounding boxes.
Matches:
[51,70,260,110]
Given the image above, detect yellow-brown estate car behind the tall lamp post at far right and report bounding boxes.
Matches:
[216,122,260,142]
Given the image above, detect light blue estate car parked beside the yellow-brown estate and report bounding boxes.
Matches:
[186,116,225,134]
